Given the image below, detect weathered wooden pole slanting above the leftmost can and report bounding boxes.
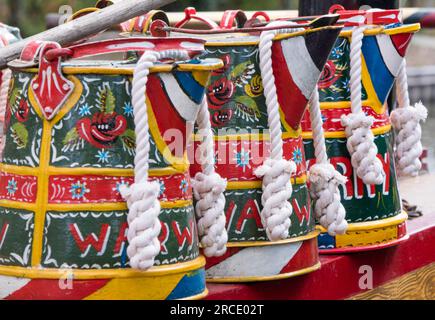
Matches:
[0,0,175,69]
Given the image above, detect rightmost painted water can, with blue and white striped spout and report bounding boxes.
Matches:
[302,10,419,253]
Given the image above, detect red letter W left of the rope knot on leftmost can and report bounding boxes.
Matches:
[69,223,110,258]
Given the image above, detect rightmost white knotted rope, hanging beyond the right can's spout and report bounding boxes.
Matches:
[391,59,427,176]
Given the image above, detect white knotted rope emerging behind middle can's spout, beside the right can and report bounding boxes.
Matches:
[309,87,347,236]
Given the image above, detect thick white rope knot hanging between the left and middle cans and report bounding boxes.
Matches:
[192,172,228,257]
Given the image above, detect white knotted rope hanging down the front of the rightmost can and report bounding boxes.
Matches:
[341,26,385,184]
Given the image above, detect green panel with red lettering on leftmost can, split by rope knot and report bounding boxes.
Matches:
[42,206,199,268]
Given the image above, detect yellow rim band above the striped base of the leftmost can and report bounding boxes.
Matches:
[0,256,205,280]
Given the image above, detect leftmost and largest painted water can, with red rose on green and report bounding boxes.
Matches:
[0,38,222,299]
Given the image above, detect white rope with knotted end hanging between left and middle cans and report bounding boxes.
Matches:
[193,98,228,257]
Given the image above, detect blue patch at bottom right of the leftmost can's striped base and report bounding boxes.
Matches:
[166,268,205,300]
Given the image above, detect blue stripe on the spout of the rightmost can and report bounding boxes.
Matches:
[362,36,394,104]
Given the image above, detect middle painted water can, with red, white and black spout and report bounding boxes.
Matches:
[138,8,341,282]
